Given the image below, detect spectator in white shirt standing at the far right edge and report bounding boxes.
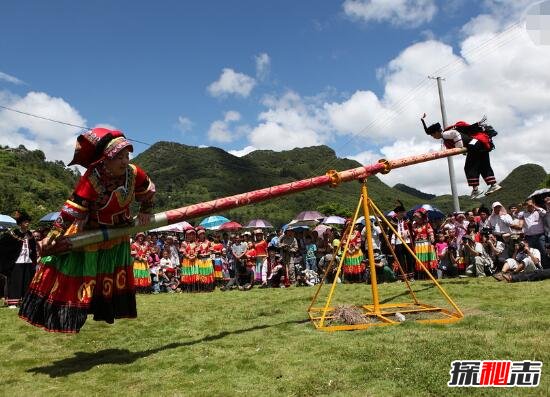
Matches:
[518,199,549,267]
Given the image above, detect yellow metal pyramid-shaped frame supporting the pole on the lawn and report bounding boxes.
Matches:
[308,180,464,332]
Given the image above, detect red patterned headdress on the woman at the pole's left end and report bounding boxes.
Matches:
[68,128,134,168]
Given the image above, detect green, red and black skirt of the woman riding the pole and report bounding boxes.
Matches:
[19,237,137,333]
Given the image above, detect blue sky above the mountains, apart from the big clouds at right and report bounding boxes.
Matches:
[0,0,550,190]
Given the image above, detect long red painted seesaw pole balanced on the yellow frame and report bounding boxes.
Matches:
[48,148,466,254]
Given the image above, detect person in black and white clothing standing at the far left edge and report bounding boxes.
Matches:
[0,211,37,309]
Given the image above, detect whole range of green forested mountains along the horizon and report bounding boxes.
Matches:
[0,142,548,229]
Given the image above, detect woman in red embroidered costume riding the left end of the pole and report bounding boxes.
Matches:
[19,128,155,333]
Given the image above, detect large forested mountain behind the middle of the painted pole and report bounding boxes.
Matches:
[134,142,417,225]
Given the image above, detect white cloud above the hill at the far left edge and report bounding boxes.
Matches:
[0,91,86,163]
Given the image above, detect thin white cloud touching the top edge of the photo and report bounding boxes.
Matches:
[343,0,437,27]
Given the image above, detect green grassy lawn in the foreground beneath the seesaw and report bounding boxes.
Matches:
[0,278,550,396]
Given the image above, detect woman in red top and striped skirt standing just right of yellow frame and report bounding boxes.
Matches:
[412,208,437,279]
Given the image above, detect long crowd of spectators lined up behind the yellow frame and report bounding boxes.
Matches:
[127,198,550,293]
